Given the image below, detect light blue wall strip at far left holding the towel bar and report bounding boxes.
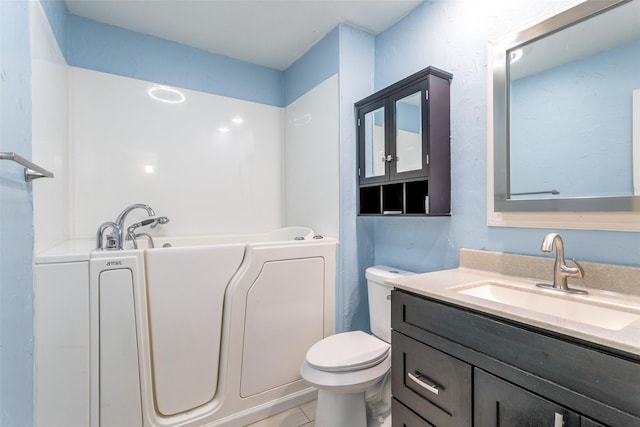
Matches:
[0,0,33,427]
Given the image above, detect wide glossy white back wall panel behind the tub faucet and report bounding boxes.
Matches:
[70,67,284,238]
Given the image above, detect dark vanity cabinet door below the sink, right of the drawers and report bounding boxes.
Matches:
[473,368,580,427]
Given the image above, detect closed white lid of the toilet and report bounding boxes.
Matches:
[307,331,390,372]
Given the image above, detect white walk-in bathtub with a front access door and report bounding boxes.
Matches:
[36,227,336,427]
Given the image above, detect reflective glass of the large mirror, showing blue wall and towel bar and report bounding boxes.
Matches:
[509,0,640,198]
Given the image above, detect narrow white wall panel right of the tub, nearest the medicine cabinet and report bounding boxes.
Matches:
[284,75,340,237]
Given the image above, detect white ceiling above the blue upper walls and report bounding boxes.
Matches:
[65,0,424,70]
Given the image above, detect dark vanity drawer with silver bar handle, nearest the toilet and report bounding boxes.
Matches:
[391,331,472,427]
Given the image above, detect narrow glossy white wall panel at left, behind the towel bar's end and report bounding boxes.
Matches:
[30,1,69,252]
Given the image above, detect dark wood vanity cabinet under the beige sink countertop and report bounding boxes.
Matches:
[391,290,640,427]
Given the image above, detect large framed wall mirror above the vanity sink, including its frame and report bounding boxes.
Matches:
[488,0,640,224]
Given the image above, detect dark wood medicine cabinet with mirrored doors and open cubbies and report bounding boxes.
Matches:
[355,67,453,216]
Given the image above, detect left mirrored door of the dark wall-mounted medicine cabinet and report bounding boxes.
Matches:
[358,99,393,184]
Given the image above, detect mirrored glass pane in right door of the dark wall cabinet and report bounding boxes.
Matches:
[396,91,422,173]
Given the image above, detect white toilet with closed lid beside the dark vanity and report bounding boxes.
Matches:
[300,265,415,427]
